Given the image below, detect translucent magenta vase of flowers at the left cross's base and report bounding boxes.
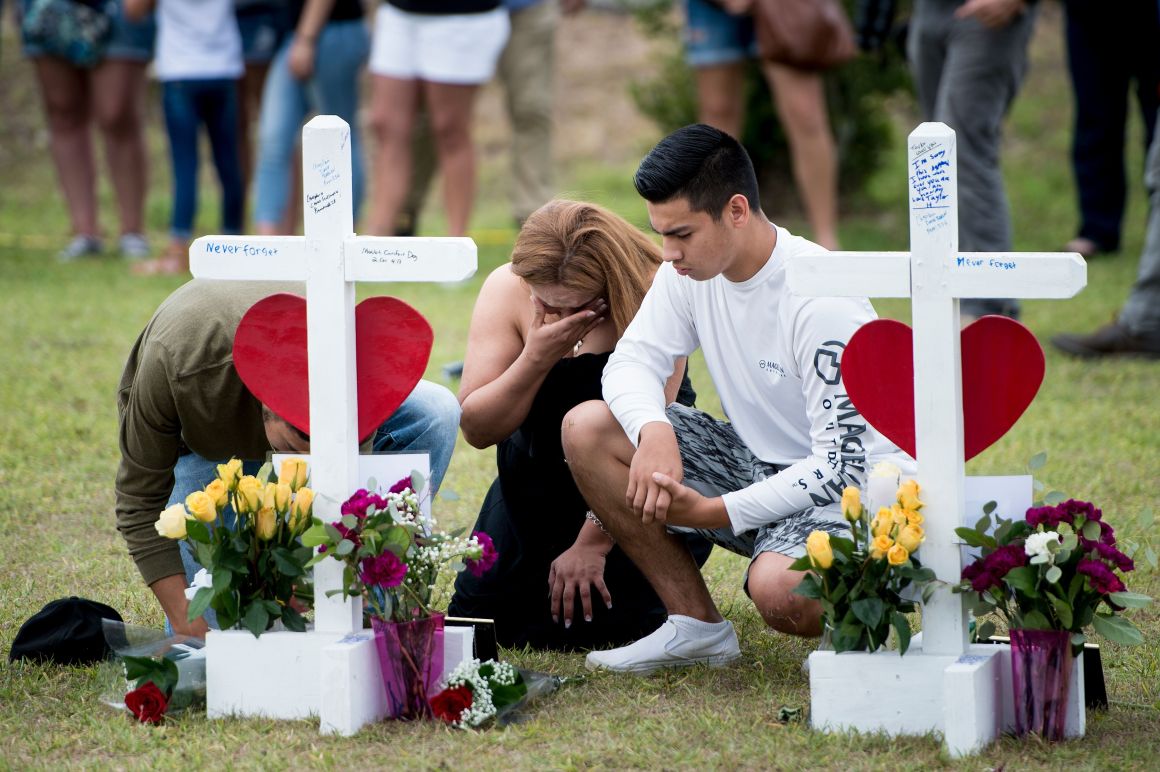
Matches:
[370,613,443,720]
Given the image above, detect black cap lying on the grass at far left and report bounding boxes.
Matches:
[8,596,122,664]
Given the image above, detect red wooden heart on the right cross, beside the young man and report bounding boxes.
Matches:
[842,316,1044,459]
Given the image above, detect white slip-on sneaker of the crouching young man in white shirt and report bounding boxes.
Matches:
[585,614,741,673]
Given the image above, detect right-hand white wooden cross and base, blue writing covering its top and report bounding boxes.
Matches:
[786,123,1087,756]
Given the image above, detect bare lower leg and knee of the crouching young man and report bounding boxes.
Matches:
[563,401,722,622]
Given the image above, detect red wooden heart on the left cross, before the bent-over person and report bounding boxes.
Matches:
[233,293,433,439]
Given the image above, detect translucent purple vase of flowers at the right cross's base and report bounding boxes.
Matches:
[1010,629,1072,740]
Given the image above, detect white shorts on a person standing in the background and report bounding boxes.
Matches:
[369,5,510,86]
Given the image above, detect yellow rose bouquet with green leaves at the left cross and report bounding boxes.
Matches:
[157,458,314,638]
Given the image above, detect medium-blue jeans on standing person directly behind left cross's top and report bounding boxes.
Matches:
[254,20,370,226]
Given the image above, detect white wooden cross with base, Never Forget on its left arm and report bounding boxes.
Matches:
[189,116,477,734]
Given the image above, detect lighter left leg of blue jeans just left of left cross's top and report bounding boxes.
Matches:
[254,37,309,235]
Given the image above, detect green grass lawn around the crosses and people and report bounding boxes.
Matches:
[0,3,1160,770]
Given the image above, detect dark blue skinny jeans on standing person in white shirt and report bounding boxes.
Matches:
[161,78,246,240]
